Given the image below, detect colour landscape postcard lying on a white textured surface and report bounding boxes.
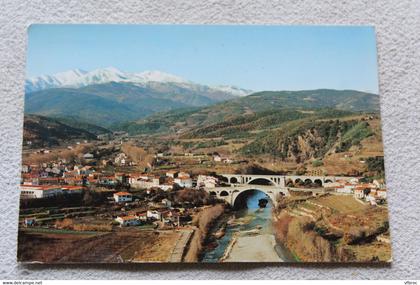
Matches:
[17,24,392,264]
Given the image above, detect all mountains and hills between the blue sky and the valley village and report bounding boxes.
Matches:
[24,68,379,162]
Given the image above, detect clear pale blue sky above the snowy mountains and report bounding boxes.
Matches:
[27,25,378,93]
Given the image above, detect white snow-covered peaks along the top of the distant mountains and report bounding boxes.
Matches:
[25,67,252,96]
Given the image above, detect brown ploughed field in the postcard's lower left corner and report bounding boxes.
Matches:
[18,229,180,263]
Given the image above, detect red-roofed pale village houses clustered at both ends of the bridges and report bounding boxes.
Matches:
[21,135,387,226]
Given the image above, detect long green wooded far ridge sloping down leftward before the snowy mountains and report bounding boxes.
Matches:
[113,89,379,135]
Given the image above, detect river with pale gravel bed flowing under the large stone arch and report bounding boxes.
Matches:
[202,191,293,262]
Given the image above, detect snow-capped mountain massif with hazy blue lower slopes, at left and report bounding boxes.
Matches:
[25,68,252,127]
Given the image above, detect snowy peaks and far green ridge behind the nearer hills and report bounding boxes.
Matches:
[25,68,379,130]
